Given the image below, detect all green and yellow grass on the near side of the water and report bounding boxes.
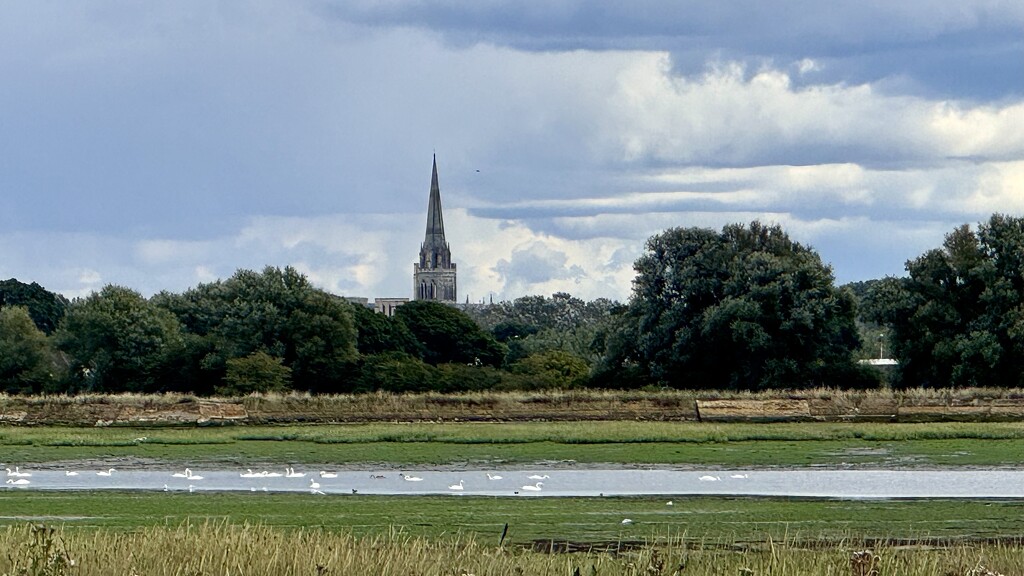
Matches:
[0,494,1024,576]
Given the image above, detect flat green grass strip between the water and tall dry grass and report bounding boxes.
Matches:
[0,491,1024,544]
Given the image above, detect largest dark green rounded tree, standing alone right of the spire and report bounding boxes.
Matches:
[602,221,859,389]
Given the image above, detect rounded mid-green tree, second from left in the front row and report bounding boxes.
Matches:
[54,285,184,393]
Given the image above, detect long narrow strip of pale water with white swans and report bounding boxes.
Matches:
[8,468,1024,498]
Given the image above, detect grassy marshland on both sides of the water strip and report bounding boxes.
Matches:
[6,399,1024,576]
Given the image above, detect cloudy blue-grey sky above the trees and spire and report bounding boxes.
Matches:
[0,0,1024,301]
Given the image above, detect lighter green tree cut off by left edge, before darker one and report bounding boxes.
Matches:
[0,306,58,394]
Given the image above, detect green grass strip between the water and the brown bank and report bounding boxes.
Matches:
[6,421,1024,467]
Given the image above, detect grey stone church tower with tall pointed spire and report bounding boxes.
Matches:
[413,155,456,302]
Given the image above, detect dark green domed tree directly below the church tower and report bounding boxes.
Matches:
[394,300,505,366]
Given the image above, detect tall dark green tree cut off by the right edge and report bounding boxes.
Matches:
[865,214,1024,387]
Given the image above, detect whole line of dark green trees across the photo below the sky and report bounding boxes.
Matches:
[0,214,1024,396]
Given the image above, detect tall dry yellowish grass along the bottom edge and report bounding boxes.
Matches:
[0,523,1024,576]
